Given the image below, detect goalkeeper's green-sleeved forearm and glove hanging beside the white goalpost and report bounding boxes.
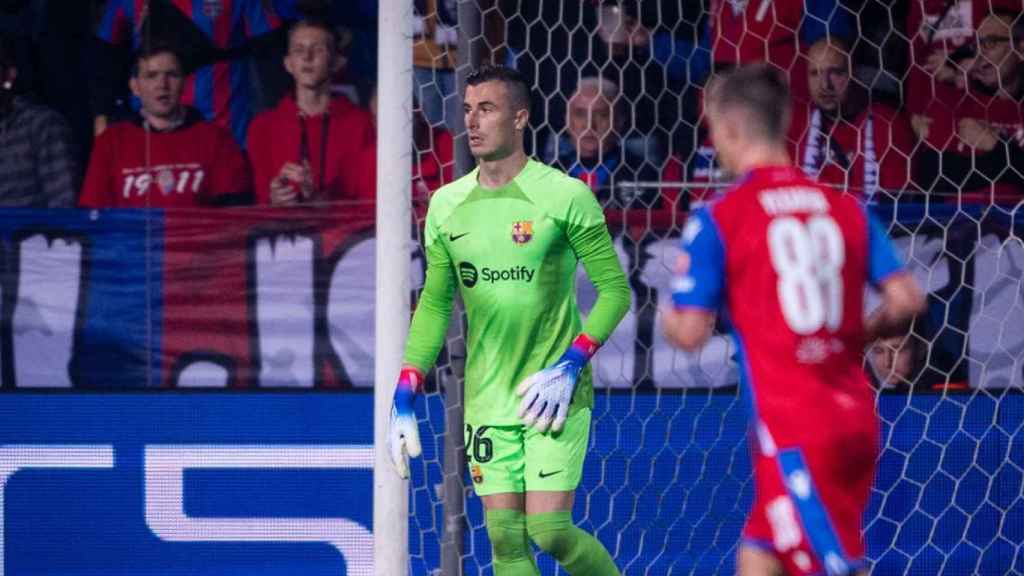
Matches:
[388,242,455,478]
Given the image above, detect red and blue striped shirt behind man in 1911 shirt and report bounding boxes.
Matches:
[97,0,287,143]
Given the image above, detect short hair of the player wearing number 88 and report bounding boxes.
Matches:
[710,63,790,141]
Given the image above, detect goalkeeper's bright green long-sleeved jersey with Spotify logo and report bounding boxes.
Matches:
[404,160,631,425]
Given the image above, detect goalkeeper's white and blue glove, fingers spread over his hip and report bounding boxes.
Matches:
[515,334,601,433]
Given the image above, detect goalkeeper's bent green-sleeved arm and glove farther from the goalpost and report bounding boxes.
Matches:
[516,222,631,433]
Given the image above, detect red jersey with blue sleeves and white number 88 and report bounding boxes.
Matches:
[673,166,902,446]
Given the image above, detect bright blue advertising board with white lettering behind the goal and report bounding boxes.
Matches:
[0,390,1024,576]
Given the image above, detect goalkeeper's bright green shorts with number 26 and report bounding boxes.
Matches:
[466,408,590,496]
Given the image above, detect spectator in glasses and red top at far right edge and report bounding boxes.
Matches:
[914,10,1024,203]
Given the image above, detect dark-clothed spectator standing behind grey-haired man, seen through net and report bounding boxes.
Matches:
[509,0,688,167]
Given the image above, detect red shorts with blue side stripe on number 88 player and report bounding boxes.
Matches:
[743,427,879,576]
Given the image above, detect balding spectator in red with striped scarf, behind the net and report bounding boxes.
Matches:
[788,37,913,199]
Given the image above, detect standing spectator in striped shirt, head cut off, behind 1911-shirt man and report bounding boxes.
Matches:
[93,0,296,143]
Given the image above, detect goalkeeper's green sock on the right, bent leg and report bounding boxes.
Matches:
[524,510,620,576]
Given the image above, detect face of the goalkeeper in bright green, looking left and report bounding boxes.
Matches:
[463,80,529,160]
